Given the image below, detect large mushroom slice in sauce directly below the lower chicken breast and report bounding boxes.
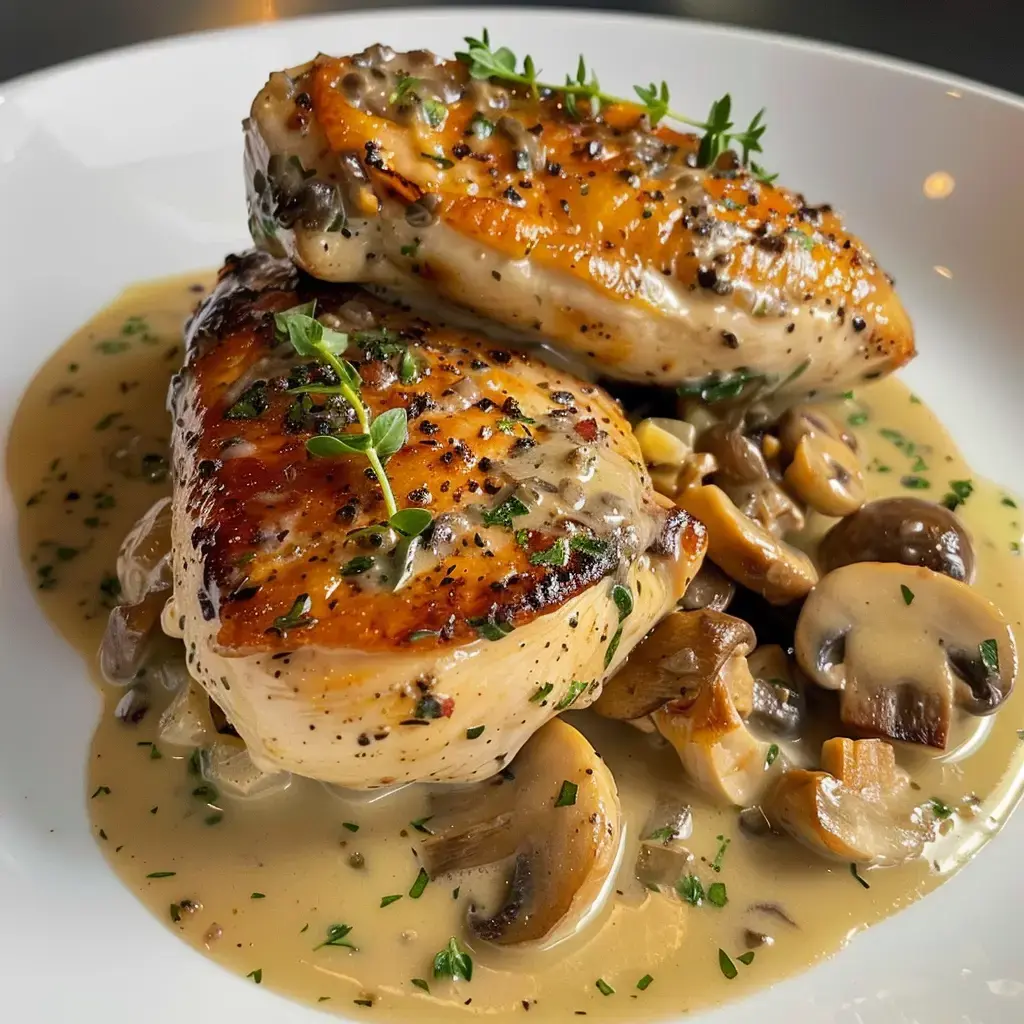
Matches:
[422,719,622,946]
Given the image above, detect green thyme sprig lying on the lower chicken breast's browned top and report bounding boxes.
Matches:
[273,300,433,539]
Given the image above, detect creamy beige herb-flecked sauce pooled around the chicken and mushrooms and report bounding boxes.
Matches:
[8,274,1024,1020]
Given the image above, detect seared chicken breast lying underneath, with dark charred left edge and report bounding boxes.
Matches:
[164,253,706,787]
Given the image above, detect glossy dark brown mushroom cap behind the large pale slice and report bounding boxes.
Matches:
[818,498,974,583]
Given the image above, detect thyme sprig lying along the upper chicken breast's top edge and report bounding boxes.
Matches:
[456,29,776,183]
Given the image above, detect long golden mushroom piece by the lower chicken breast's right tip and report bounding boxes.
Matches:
[678,484,818,604]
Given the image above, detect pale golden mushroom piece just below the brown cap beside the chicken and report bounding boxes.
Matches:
[651,656,771,807]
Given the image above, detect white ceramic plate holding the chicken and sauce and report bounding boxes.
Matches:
[0,10,1024,1024]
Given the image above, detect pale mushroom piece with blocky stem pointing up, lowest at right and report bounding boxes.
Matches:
[764,739,933,864]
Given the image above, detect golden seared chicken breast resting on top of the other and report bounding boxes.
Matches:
[246,46,914,395]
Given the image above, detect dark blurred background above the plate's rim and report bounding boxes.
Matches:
[0,0,1024,93]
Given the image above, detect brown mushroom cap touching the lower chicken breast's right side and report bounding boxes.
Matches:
[593,608,757,721]
